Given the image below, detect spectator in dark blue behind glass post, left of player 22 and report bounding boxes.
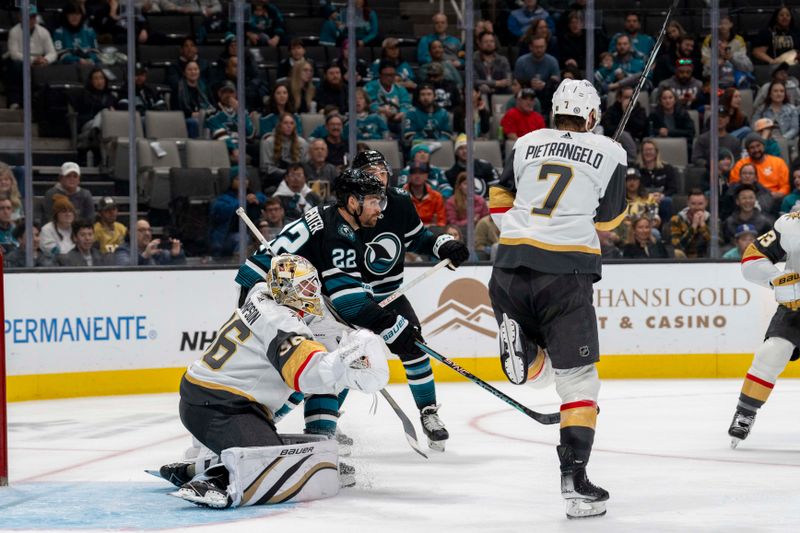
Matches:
[208,168,266,257]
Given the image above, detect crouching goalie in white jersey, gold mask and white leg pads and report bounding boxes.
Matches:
[160,254,389,508]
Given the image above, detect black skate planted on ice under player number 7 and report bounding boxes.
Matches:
[556,446,609,520]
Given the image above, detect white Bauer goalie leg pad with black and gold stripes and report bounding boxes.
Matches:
[222,435,340,507]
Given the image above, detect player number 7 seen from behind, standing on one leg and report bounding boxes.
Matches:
[489,79,627,518]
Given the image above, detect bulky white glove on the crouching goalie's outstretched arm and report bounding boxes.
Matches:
[319,329,389,394]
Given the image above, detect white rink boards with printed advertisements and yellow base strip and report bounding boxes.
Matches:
[4,263,800,400]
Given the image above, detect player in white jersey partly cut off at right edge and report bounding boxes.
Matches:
[728,212,800,448]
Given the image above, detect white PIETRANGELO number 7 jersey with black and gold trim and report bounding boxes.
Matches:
[489,129,627,279]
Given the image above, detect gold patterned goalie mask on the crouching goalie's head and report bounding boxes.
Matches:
[267,254,323,316]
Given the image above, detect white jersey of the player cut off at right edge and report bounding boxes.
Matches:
[742,213,800,287]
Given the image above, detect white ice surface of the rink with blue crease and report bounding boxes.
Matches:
[0,379,800,533]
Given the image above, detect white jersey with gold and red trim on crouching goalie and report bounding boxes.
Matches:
[180,282,354,418]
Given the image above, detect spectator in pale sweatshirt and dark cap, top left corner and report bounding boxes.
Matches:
[6,5,58,109]
